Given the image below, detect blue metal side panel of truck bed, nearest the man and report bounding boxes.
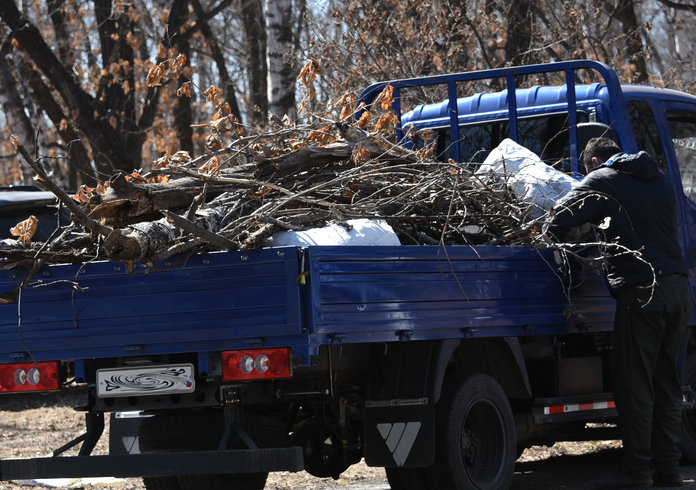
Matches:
[308,246,614,343]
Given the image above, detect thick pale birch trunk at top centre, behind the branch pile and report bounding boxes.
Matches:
[264,0,296,120]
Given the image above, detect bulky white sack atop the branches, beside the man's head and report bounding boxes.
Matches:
[475,138,578,219]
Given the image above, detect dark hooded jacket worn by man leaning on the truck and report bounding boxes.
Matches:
[549,151,687,290]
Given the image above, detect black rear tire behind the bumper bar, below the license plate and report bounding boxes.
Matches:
[138,410,287,490]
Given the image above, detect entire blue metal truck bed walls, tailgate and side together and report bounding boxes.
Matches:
[0,246,614,362]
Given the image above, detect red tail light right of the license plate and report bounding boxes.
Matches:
[222,347,292,381]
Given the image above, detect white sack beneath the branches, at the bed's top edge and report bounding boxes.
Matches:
[265,219,401,247]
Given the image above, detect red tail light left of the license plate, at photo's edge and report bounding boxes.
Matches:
[0,361,60,393]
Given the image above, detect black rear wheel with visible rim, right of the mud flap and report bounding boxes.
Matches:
[428,374,517,490]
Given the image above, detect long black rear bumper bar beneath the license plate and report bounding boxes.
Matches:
[0,447,304,481]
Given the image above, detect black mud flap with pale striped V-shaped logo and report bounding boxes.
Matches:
[364,398,435,467]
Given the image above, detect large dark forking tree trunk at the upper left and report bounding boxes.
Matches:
[0,0,194,180]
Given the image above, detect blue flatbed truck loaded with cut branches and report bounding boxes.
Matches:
[0,60,696,490]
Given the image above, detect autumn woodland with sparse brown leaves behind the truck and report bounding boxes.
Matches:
[0,0,696,189]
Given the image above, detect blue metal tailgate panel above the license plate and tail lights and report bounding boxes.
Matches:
[0,248,301,362]
